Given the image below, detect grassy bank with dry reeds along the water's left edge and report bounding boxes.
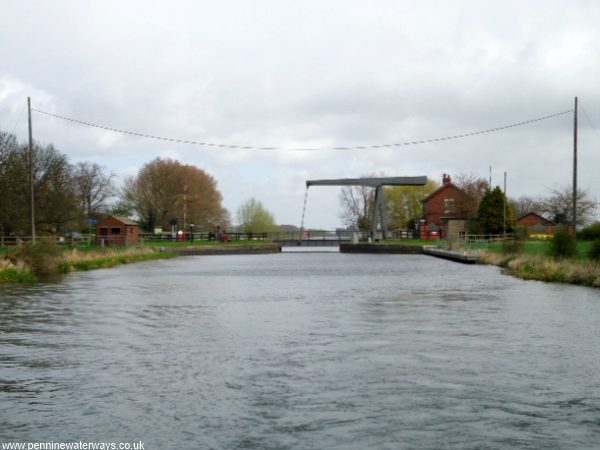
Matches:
[0,244,174,283]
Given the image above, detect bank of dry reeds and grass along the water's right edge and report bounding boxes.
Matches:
[480,251,600,288]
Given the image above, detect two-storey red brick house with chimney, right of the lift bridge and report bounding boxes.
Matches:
[419,174,468,238]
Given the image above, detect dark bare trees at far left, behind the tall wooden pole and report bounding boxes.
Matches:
[0,131,116,235]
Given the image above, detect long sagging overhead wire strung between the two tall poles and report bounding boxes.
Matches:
[31,108,573,152]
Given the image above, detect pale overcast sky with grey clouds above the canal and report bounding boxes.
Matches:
[0,0,600,229]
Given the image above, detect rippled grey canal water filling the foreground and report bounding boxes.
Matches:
[0,253,600,449]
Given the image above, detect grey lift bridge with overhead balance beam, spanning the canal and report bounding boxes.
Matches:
[280,176,427,246]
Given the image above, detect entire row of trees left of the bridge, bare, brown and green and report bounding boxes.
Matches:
[0,131,276,236]
